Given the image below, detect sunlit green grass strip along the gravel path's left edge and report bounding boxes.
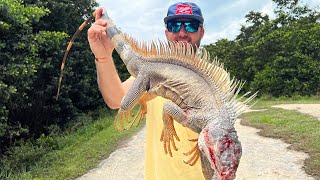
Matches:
[0,107,144,179]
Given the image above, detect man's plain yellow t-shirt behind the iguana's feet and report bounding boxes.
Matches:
[145,97,204,180]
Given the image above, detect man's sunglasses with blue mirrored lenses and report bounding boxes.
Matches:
[167,21,201,33]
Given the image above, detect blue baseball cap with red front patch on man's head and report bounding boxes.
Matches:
[163,2,204,24]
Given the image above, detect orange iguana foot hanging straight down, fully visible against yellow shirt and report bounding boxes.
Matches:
[160,114,180,157]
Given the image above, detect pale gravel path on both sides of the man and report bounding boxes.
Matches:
[78,104,320,180]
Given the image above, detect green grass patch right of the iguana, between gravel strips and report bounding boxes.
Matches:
[241,98,320,178]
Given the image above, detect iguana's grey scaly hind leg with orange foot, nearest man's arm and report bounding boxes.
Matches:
[114,74,150,130]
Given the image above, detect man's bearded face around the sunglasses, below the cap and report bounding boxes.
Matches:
[165,19,204,48]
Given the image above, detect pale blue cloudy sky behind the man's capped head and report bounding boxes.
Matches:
[97,0,320,44]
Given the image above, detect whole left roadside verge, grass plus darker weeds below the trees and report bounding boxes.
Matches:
[0,107,144,180]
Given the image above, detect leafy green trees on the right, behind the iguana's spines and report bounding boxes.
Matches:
[206,0,320,97]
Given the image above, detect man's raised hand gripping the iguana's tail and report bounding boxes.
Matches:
[88,8,114,60]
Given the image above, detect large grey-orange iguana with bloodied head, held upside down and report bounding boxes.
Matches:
[57,8,256,179]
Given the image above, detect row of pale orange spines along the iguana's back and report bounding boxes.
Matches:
[107,19,257,122]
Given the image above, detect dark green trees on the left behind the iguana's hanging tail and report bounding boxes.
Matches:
[0,0,103,153]
